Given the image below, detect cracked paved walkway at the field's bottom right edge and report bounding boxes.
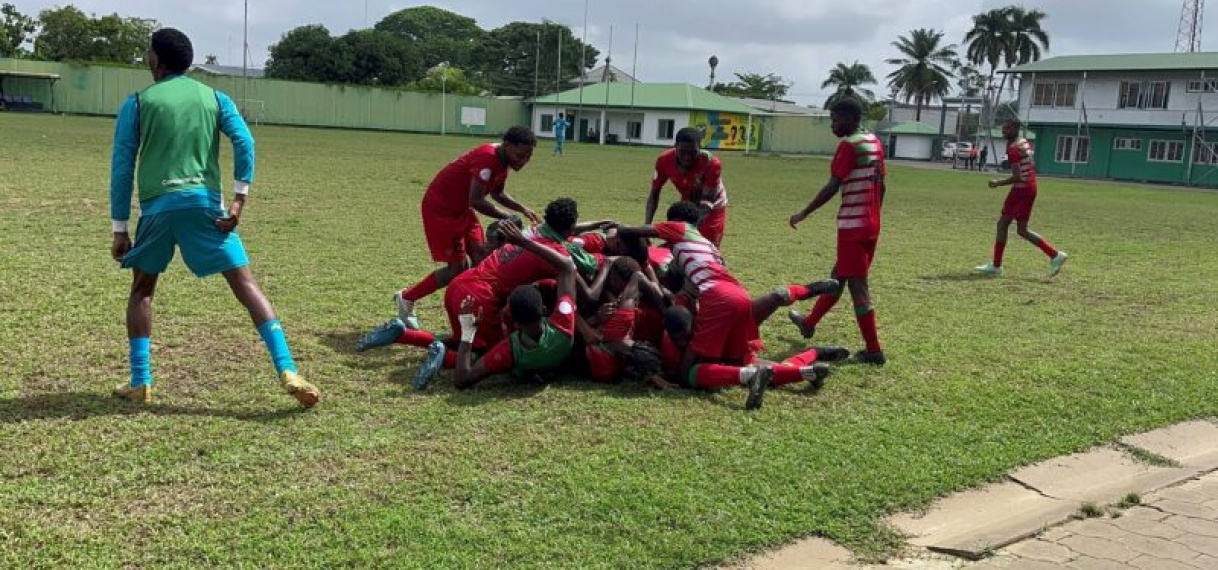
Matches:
[741,421,1218,570]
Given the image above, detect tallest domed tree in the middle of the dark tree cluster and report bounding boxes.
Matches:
[375,6,486,69]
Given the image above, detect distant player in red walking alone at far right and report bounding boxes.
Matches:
[973,121,1068,279]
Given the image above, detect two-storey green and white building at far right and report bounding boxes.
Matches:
[1004,52,1218,186]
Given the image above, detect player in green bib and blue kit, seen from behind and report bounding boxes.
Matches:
[110,28,322,407]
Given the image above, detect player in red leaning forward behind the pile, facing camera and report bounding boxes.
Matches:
[643,127,727,248]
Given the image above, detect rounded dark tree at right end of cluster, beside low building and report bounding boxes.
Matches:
[473,21,600,96]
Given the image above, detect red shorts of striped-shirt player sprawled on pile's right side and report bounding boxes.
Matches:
[689,281,762,363]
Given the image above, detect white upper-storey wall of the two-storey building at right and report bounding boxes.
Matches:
[1019,71,1218,127]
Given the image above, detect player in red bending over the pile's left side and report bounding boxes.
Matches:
[393,127,541,329]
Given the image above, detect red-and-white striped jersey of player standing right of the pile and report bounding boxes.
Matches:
[829,128,887,238]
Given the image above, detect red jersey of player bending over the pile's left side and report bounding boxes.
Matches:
[423,144,508,216]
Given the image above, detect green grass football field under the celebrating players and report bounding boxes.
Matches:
[0,114,1218,568]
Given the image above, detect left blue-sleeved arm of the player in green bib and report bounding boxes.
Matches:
[110,95,140,261]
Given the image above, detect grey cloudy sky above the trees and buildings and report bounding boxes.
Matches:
[6,0,1198,104]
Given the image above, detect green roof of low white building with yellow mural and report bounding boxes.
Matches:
[531,83,764,114]
